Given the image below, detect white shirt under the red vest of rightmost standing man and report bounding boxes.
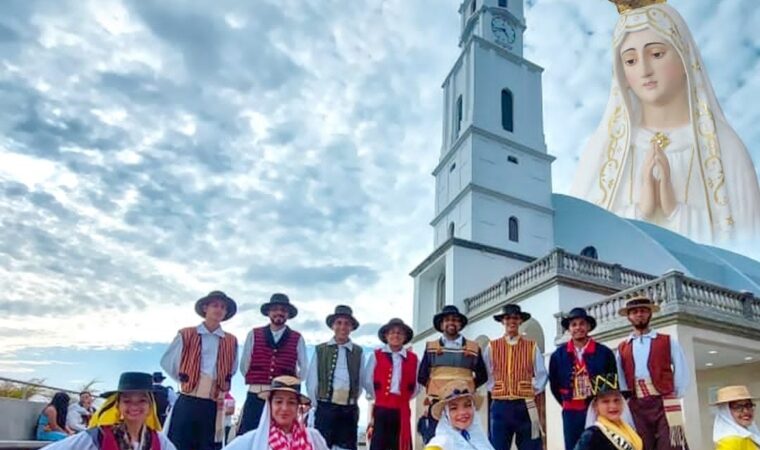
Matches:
[615,330,689,398]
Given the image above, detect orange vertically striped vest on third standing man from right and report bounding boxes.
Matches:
[490,337,536,400]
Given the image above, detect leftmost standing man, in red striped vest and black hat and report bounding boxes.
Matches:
[161,291,237,450]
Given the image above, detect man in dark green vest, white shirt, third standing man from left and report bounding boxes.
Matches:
[306,305,364,450]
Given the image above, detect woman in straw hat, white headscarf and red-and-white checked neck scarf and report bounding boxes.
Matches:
[224,375,328,450]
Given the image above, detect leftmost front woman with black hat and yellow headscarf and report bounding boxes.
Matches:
[45,372,176,450]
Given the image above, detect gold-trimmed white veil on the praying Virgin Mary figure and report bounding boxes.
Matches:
[570,4,760,241]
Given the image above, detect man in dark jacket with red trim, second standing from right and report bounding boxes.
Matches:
[549,308,617,450]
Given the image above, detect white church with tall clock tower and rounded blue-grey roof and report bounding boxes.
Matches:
[411,0,760,450]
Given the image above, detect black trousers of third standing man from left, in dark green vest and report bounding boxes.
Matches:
[314,402,359,450]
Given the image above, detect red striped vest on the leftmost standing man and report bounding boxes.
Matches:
[179,327,237,397]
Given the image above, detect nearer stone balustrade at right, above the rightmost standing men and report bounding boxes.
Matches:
[556,271,760,339]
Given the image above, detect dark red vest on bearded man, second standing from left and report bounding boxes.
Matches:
[245,325,301,385]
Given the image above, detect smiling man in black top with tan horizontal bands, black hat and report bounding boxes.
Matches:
[417,305,488,443]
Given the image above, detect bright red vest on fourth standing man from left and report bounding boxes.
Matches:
[372,349,417,408]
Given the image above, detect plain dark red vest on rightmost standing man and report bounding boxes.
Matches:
[618,333,674,395]
